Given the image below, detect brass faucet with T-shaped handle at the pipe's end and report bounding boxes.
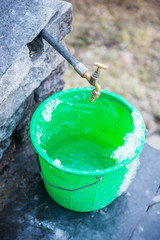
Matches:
[82,62,108,102]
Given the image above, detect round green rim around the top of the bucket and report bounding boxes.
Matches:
[30,87,145,176]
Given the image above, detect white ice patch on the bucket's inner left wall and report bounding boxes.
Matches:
[42,98,62,122]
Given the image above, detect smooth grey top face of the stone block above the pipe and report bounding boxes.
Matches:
[0,0,62,79]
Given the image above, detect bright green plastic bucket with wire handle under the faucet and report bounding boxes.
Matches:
[30,88,145,212]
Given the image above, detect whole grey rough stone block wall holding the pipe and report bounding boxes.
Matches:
[0,0,72,164]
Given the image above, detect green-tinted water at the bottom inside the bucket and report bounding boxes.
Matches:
[47,134,115,171]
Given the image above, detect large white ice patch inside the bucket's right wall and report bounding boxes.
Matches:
[110,110,144,163]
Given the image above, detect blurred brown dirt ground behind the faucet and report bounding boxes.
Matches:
[64,0,160,133]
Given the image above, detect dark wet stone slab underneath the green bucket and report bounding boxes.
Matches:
[0,144,160,240]
